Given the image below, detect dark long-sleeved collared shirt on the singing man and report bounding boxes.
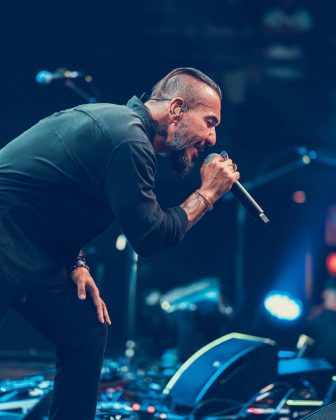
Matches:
[0,97,187,298]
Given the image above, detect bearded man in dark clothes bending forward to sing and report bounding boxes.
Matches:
[0,68,239,420]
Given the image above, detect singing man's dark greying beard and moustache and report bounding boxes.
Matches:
[169,121,194,177]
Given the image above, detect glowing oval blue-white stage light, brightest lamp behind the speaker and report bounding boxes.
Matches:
[264,290,302,321]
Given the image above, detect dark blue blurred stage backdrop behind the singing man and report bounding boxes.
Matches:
[0,0,336,358]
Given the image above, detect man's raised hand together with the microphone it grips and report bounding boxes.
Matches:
[200,151,269,223]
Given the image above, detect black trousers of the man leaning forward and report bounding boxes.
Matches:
[0,270,107,420]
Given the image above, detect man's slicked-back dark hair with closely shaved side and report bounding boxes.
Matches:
[149,67,222,108]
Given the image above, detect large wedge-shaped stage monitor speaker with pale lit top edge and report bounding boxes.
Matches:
[163,333,277,412]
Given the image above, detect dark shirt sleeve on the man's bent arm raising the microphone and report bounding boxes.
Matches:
[103,141,188,256]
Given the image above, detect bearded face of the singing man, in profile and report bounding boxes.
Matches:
[167,89,220,175]
